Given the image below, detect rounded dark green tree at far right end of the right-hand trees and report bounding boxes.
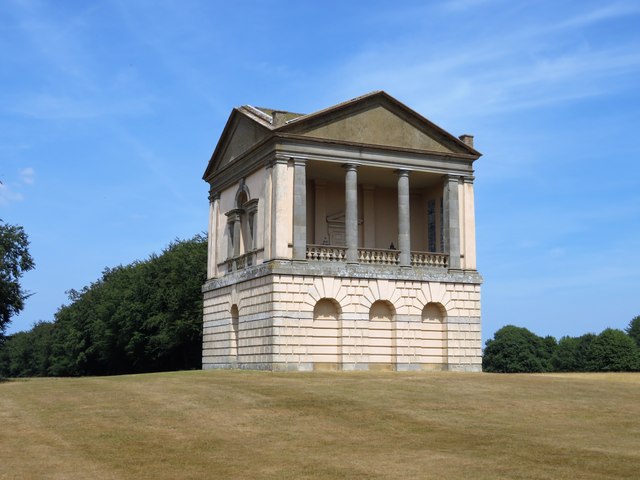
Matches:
[587,328,640,372]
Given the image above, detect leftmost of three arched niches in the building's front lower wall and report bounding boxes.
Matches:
[309,298,342,370]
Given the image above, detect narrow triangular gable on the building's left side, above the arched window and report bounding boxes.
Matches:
[204,107,271,179]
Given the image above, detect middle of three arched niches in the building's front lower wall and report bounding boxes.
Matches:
[369,300,397,370]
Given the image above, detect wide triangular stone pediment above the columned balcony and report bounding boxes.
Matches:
[278,92,480,156]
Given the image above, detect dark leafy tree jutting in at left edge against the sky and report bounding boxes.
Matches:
[0,220,35,341]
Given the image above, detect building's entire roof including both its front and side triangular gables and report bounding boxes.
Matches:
[204,91,480,180]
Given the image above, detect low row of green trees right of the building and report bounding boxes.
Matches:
[482,316,640,373]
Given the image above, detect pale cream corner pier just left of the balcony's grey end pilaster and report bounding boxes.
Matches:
[271,158,291,258]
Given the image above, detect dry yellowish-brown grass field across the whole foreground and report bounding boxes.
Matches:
[0,371,640,480]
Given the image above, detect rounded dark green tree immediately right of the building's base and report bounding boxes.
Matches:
[482,325,555,373]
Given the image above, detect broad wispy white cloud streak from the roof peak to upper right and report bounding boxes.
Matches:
[330,1,640,122]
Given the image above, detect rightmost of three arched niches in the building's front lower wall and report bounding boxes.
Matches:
[420,302,447,368]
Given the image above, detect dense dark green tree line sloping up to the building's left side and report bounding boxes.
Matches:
[0,235,207,377]
